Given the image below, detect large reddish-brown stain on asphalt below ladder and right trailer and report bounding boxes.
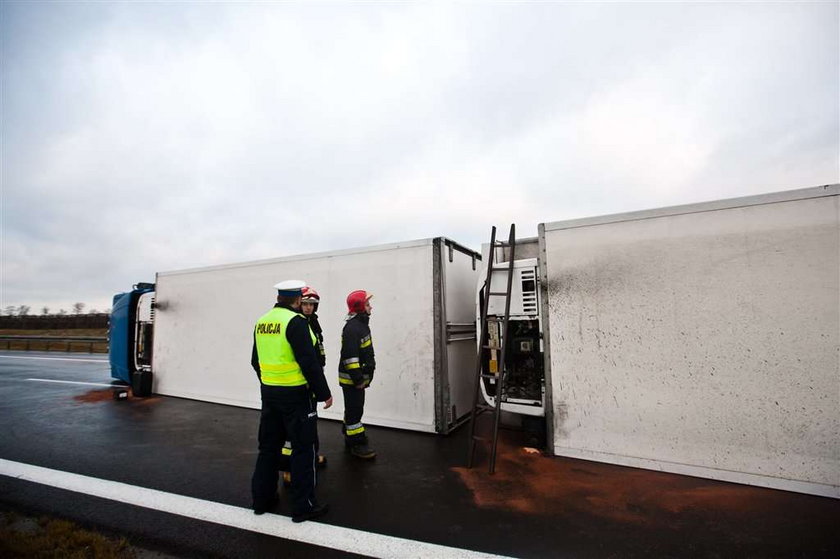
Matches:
[452,433,840,527]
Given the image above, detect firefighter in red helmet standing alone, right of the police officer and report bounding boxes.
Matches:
[338,290,376,460]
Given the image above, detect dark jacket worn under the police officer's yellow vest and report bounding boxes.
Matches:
[251,303,332,402]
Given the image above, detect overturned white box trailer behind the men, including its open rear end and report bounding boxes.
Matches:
[152,237,481,433]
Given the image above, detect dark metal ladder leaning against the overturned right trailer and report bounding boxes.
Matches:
[467,224,516,474]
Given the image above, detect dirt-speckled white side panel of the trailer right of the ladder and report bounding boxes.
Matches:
[541,185,840,497]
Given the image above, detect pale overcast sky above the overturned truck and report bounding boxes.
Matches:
[0,1,840,313]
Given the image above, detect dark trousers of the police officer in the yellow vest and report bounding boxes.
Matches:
[251,385,318,514]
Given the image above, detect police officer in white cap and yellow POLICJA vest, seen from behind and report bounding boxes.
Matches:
[251,280,332,522]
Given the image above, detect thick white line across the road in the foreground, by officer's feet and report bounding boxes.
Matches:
[0,458,508,559]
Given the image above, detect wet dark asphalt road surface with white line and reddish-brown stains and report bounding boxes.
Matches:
[0,352,840,558]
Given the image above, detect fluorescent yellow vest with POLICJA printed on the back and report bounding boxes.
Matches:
[254,307,317,386]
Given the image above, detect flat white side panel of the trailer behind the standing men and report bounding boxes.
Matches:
[154,239,440,432]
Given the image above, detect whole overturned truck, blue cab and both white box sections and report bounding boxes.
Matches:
[111,185,840,498]
